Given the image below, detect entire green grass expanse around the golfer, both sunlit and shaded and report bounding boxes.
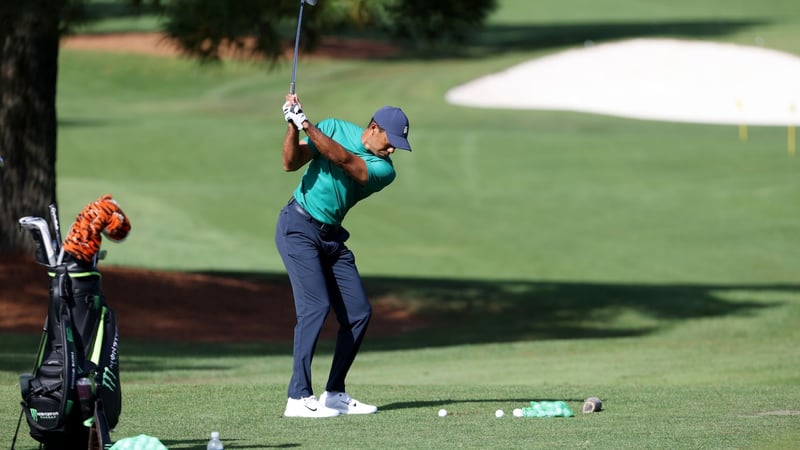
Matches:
[0,0,800,449]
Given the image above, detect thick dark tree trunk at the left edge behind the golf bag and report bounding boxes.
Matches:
[0,0,67,256]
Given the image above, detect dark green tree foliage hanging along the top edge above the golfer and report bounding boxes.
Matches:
[132,0,497,61]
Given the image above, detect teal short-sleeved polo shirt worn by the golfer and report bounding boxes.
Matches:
[294,119,396,225]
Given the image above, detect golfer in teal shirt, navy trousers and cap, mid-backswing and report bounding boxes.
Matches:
[275,94,411,417]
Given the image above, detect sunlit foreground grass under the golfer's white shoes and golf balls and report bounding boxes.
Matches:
[6,310,800,448]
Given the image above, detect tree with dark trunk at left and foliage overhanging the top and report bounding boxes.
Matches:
[0,0,495,254]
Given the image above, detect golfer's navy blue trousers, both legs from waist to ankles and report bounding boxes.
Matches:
[275,199,372,398]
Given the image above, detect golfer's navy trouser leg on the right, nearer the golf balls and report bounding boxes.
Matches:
[325,248,372,392]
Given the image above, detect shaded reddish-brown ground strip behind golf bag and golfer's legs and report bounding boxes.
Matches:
[0,256,422,342]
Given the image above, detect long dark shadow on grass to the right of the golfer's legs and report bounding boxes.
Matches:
[202,273,800,350]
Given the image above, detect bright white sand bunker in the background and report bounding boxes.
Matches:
[446,39,800,126]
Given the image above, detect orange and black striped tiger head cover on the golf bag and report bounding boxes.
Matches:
[64,194,131,262]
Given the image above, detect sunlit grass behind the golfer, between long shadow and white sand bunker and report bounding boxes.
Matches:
[53,52,800,281]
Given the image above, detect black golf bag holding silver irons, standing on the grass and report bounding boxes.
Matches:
[11,205,122,450]
